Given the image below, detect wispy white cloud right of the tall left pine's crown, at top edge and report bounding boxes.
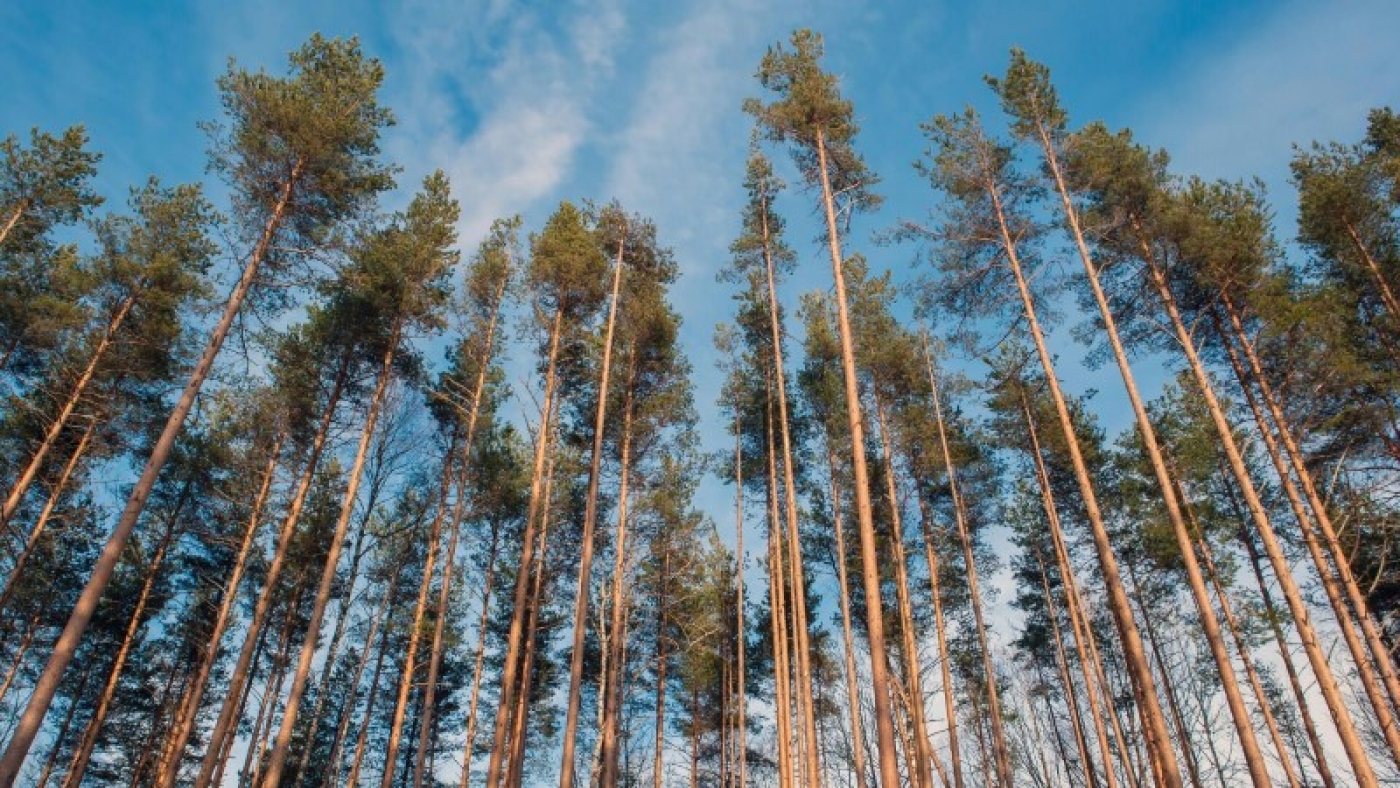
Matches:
[392,0,626,244]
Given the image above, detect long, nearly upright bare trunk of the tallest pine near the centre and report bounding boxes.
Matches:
[816,129,899,788]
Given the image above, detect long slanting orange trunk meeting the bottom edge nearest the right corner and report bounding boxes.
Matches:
[1133,232,1377,788]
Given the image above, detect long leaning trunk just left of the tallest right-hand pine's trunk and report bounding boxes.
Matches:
[986,152,1182,788]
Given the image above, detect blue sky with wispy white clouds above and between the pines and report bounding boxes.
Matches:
[8,0,1400,783]
